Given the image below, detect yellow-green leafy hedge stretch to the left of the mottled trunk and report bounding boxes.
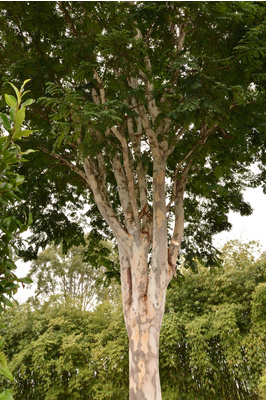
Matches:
[0,297,127,400]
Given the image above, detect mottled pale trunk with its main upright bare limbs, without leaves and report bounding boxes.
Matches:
[84,145,179,400]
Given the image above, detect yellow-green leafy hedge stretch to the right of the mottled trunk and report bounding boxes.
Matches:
[161,241,266,400]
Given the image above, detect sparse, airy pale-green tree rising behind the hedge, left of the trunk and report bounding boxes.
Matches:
[28,237,119,310]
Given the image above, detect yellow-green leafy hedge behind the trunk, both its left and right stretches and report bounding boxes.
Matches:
[2,242,266,400]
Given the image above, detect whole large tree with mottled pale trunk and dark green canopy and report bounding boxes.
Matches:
[1,2,265,400]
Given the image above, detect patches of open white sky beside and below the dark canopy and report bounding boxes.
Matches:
[15,188,266,302]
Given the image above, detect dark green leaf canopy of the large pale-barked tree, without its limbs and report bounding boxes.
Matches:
[0,1,265,265]
